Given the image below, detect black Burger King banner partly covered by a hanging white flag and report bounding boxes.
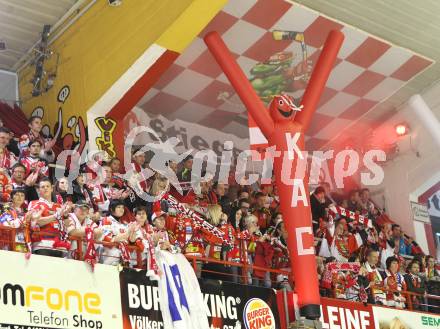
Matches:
[120,269,280,329]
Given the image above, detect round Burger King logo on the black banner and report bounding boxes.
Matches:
[243,298,275,329]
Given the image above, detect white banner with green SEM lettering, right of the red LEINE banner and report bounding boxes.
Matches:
[373,307,440,329]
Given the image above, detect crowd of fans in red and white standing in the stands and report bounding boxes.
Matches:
[0,117,439,309]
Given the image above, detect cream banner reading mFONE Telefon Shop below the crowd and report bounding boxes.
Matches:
[0,251,122,329]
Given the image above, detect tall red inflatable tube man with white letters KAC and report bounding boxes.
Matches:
[205,31,344,319]
